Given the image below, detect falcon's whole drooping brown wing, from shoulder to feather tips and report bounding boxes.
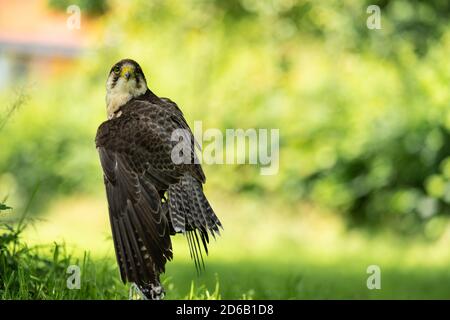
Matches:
[96,101,182,283]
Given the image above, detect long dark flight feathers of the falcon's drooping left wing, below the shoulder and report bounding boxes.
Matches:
[98,147,172,283]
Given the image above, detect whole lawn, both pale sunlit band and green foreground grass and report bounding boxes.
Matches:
[0,197,450,299]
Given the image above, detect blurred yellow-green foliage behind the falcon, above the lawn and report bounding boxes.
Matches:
[0,0,450,233]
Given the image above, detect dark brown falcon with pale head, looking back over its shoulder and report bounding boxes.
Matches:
[95,59,222,299]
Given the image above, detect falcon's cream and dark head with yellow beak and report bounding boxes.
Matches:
[106,59,147,118]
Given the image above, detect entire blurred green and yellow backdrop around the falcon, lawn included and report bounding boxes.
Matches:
[0,0,450,299]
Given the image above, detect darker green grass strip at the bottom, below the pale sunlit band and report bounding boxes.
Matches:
[0,238,450,299]
